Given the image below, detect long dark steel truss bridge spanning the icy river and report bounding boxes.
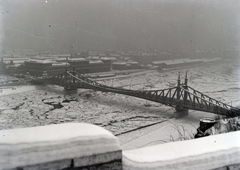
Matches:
[32,69,240,117]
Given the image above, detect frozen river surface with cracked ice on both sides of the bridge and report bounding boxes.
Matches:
[0,60,240,149]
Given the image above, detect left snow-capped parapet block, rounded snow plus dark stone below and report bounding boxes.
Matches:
[0,123,122,170]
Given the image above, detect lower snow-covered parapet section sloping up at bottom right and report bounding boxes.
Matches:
[122,132,240,170]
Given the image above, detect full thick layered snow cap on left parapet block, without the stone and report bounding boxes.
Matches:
[0,123,120,170]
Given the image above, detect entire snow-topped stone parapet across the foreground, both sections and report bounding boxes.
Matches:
[0,123,240,170]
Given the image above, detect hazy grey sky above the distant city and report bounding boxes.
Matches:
[0,0,240,52]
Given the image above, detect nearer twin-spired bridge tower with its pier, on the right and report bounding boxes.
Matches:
[174,72,188,118]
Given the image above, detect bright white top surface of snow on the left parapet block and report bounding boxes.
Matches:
[0,123,115,144]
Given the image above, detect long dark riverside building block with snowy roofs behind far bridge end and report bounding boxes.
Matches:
[24,57,113,76]
